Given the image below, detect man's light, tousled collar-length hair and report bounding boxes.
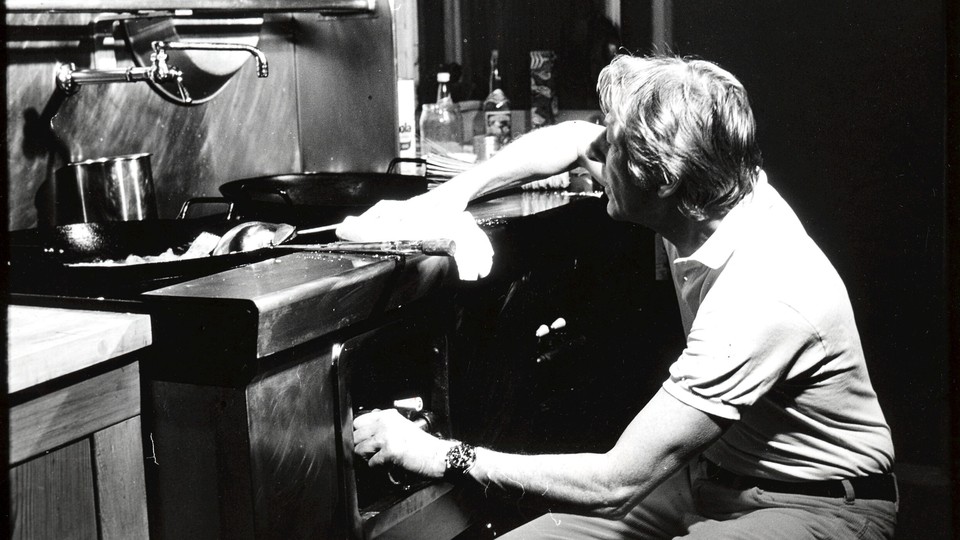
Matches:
[597,55,761,219]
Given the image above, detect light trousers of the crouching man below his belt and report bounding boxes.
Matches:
[500,460,897,540]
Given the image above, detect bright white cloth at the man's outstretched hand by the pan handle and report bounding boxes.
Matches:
[337,201,493,281]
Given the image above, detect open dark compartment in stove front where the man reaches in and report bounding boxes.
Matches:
[334,317,471,540]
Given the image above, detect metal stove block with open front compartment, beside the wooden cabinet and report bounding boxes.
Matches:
[143,247,470,538]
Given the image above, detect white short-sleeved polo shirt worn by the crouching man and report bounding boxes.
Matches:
[663,173,894,480]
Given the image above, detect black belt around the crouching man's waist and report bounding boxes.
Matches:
[704,460,897,502]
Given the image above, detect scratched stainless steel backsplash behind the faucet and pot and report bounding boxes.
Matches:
[6,0,397,230]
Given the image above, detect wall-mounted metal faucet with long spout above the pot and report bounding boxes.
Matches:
[56,41,270,103]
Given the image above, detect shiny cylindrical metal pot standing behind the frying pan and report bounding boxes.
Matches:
[54,153,157,225]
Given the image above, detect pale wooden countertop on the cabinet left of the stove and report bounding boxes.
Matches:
[7,306,152,393]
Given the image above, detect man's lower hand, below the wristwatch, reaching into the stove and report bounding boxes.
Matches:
[353,409,453,478]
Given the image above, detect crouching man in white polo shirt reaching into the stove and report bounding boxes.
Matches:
[354,56,897,540]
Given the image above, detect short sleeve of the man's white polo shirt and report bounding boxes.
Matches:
[663,300,823,420]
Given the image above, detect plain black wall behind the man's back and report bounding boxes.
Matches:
[664,0,949,465]
